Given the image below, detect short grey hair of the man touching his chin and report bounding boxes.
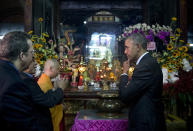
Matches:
[125,33,147,50]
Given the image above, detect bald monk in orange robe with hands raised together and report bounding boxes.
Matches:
[38,59,65,131]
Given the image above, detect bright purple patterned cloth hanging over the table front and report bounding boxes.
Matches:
[71,114,128,131]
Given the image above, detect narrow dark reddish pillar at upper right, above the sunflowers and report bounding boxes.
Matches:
[179,0,187,42]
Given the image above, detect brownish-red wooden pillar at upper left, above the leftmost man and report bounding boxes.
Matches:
[24,0,32,32]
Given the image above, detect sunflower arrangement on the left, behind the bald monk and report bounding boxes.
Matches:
[28,18,58,70]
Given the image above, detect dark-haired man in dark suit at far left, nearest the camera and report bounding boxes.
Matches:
[0,31,39,131]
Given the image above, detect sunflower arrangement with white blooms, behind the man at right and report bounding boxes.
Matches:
[157,17,192,83]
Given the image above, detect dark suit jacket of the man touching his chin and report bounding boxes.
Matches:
[119,54,165,131]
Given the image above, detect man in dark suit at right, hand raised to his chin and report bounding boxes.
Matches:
[119,33,166,131]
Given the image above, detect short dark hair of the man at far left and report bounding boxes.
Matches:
[0,31,30,61]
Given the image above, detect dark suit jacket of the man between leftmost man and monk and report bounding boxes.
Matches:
[21,73,64,131]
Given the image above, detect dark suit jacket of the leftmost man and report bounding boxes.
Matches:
[0,60,39,131]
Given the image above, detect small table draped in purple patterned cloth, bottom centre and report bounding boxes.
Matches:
[71,110,128,131]
